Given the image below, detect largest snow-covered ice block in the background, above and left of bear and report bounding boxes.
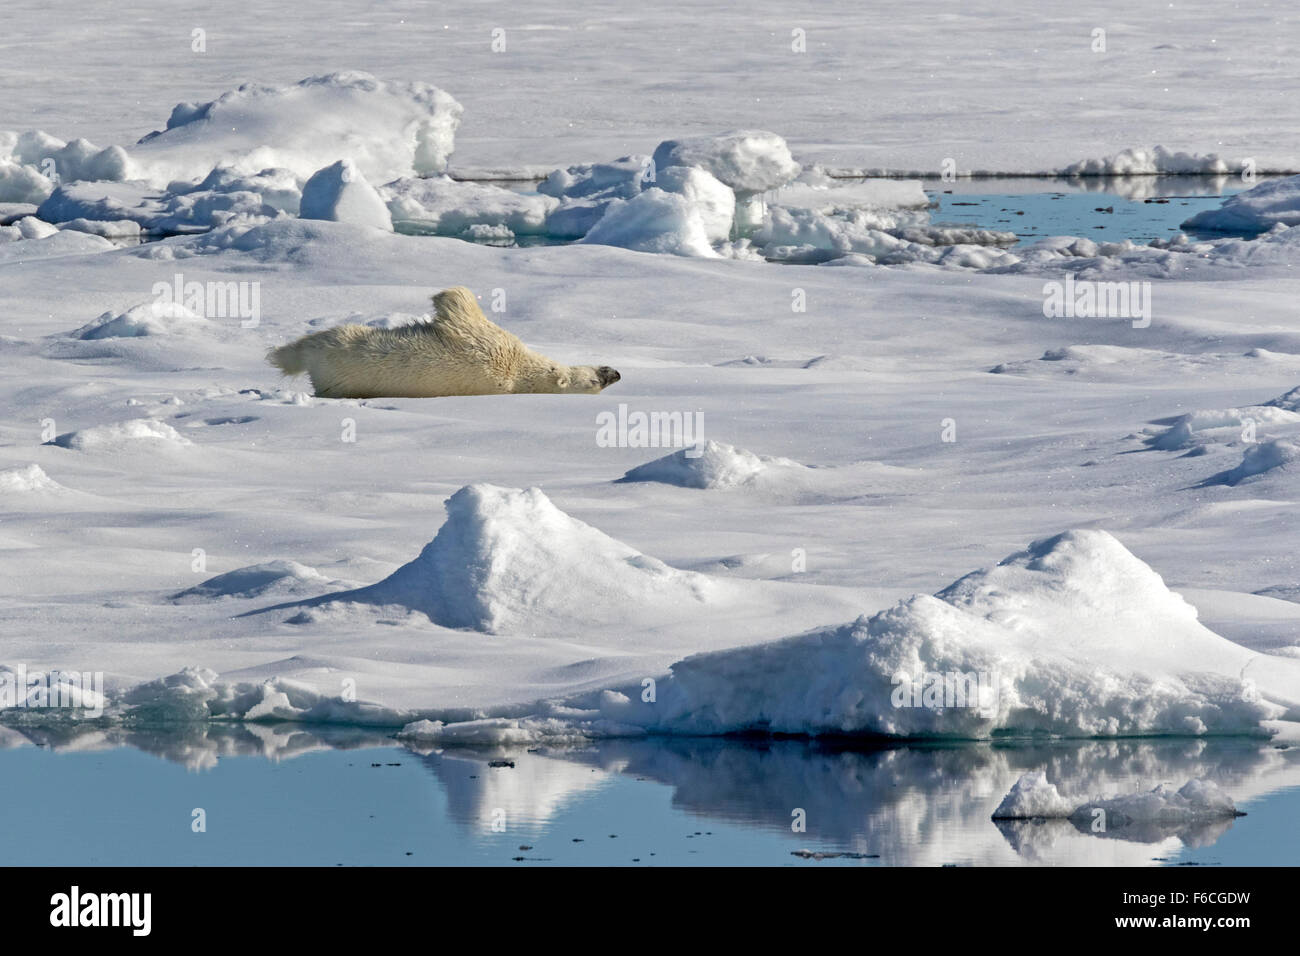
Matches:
[130,72,462,186]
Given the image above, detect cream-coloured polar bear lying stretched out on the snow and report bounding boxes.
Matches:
[267,286,620,398]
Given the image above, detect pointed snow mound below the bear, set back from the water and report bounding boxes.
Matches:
[330,484,714,633]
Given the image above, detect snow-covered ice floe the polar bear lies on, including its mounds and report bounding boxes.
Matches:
[0,219,1300,736]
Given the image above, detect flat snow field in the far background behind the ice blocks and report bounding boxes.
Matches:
[0,0,1300,175]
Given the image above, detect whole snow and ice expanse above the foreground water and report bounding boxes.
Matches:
[0,0,1300,749]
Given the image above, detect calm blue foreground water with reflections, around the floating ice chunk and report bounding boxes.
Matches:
[0,724,1300,866]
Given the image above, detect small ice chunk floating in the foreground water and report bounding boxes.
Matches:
[993,771,1245,830]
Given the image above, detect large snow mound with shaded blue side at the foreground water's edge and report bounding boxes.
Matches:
[602,531,1300,737]
